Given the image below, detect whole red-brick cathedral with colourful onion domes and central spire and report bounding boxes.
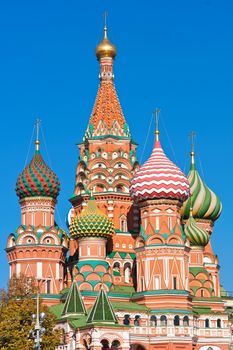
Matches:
[6,25,231,350]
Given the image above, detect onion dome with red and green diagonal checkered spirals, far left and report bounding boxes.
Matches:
[16,150,60,199]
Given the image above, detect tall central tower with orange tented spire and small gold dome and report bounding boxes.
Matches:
[70,25,138,232]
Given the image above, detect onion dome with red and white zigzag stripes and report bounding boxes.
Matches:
[130,141,189,202]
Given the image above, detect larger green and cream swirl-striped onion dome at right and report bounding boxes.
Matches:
[181,154,222,221]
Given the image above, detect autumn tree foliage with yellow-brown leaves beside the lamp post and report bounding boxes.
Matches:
[0,275,60,350]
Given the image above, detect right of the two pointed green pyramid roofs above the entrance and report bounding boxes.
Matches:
[87,289,118,323]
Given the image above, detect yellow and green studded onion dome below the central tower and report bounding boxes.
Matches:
[69,199,115,238]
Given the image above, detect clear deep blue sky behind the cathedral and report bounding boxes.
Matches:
[0,0,233,290]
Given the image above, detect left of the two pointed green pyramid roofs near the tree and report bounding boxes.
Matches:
[62,282,87,317]
